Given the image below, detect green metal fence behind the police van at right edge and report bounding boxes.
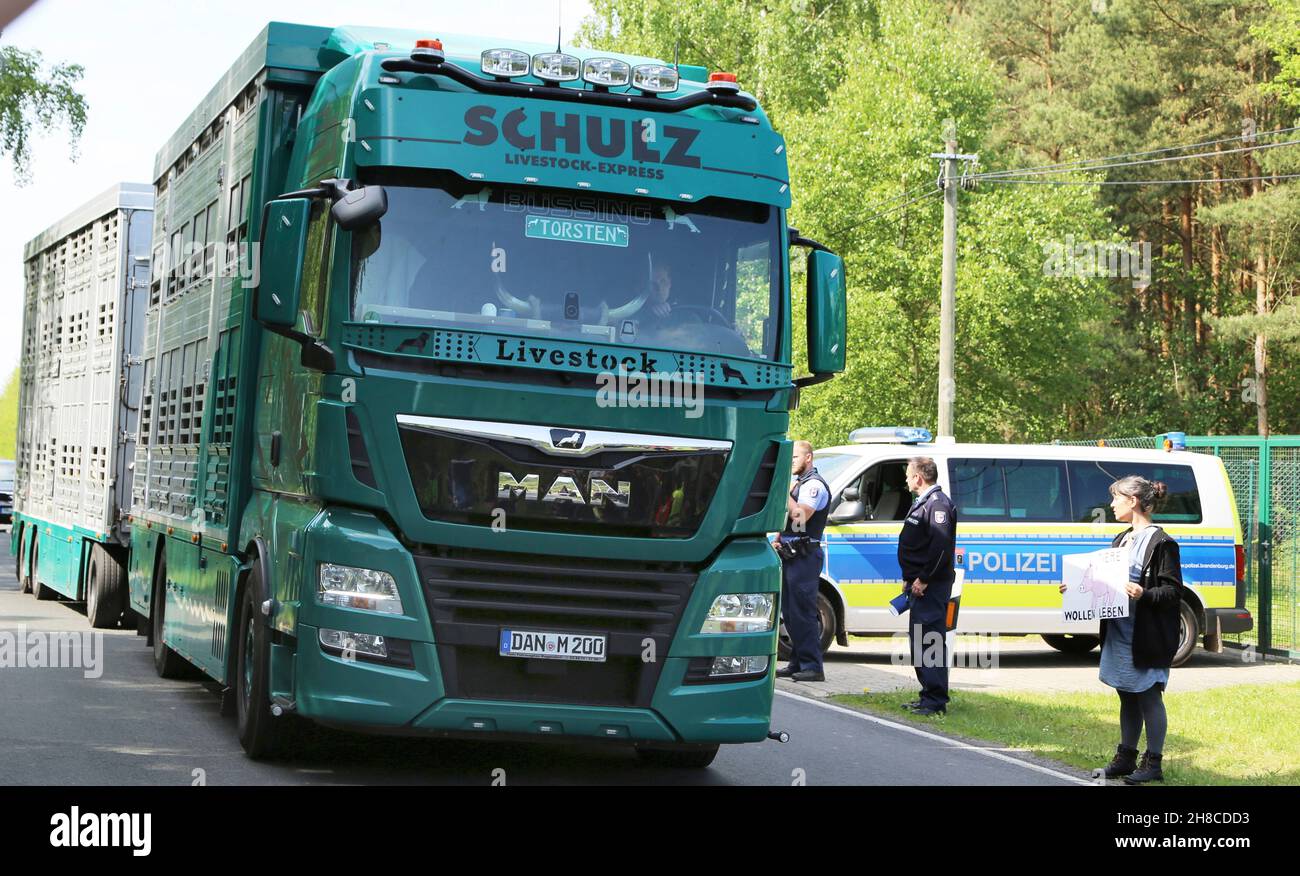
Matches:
[1058,435,1300,658]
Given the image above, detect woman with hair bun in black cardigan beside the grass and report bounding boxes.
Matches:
[1061,474,1183,785]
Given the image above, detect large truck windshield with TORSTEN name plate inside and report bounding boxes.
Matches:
[352,174,783,360]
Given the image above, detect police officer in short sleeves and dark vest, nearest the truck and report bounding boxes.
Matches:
[772,441,831,681]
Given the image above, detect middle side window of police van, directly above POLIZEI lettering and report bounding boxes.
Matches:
[948,459,1070,522]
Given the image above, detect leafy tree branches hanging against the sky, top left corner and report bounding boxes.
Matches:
[0,45,87,183]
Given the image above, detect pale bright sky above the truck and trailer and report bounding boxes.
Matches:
[0,0,590,371]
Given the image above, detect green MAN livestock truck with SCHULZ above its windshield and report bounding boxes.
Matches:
[13,23,845,766]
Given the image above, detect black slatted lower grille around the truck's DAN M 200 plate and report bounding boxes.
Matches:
[416,548,697,708]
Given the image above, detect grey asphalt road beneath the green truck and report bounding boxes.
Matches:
[0,528,1082,786]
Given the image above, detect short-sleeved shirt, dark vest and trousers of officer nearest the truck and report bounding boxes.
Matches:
[780,467,831,672]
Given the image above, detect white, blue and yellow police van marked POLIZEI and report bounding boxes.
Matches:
[785,428,1252,665]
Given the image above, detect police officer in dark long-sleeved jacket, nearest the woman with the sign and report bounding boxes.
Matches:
[898,456,957,715]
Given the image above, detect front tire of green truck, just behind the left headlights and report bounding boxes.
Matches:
[234,560,295,760]
